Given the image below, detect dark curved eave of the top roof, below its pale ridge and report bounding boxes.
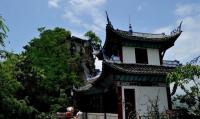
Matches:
[103,26,182,50]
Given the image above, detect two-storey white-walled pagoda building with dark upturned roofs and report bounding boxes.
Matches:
[74,13,182,119]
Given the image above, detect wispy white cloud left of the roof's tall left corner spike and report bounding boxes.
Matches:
[63,0,106,33]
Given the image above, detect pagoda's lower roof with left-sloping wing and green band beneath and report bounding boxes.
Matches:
[75,61,174,92]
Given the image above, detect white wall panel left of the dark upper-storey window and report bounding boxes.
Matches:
[122,46,136,63]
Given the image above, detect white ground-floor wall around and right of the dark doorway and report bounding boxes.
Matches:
[122,86,168,117]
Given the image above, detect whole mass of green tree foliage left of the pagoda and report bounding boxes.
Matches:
[0,24,95,119]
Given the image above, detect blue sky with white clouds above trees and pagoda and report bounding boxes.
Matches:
[0,0,200,67]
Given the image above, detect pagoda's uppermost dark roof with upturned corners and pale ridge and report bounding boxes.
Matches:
[103,22,182,51]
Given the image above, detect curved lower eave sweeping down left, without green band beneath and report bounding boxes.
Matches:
[74,61,174,93]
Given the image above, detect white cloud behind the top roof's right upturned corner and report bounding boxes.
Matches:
[159,4,200,63]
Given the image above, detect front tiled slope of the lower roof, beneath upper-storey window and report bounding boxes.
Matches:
[103,62,174,75]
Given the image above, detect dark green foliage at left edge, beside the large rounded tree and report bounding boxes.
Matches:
[0,54,36,119]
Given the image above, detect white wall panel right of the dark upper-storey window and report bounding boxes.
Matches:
[147,48,160,65]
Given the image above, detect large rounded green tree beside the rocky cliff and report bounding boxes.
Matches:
[15,27,81,118]
